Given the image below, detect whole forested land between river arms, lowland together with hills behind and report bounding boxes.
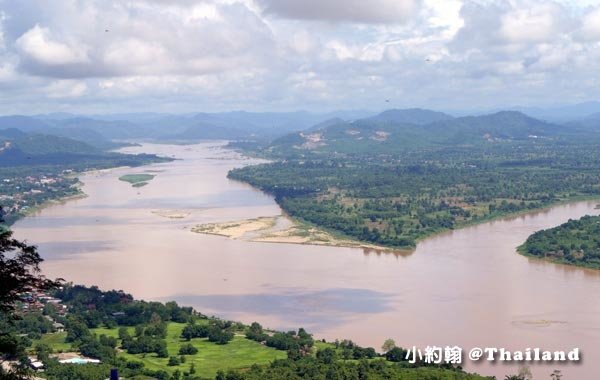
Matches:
[229,113,600,248]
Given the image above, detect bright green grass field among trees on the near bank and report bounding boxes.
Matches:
[35,323,287,378]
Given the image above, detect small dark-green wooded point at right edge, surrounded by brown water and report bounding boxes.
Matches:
[519,215,600,269]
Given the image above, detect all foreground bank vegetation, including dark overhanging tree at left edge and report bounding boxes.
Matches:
[0,217,556,380]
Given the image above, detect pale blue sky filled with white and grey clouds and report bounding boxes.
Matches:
[0,0,600,114]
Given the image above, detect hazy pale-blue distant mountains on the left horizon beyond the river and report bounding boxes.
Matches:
[0,111,378,145]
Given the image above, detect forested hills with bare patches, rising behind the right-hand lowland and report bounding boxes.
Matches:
[266,110,600,156]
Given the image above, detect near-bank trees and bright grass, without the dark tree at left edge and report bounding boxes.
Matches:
[10,284,496,379]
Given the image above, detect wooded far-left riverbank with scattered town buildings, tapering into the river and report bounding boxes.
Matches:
[0,129,169,225]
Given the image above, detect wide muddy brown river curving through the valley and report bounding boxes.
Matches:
[14,142,600,380]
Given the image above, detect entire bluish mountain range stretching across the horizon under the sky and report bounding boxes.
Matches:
[0,106,600,161]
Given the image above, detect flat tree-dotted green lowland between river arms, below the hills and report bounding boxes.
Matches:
[229,140,600,248]
